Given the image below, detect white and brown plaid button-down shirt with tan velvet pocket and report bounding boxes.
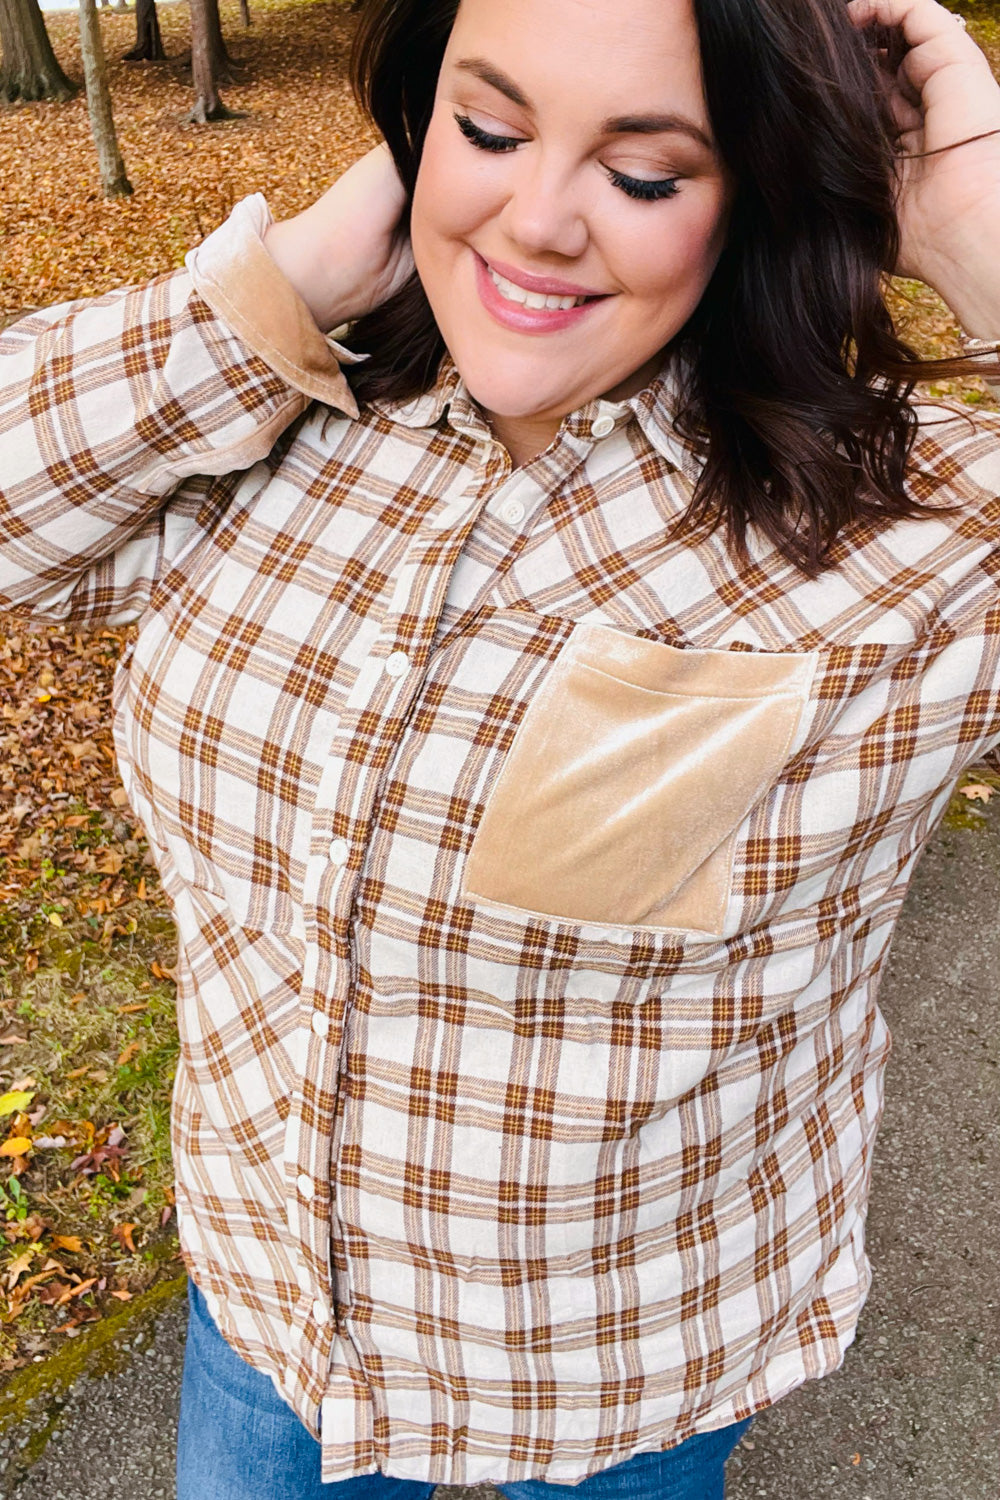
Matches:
[0,198,1000,1484]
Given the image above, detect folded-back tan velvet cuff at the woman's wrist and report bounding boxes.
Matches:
[184,192,364,417]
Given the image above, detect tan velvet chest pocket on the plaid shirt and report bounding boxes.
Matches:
[463,626,816,936]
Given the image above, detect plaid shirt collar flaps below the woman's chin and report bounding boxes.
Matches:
[372,354,705,482]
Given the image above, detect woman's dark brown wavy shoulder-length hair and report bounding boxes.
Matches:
[352,0,982,575]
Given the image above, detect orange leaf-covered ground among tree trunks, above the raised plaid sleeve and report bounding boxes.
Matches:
[0,0,373,317]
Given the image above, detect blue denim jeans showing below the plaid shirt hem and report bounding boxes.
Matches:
[177,1281,750,1500]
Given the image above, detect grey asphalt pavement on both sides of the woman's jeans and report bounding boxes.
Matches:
[0,798,1000,1500]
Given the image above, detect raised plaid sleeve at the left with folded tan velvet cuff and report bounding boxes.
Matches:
[0,195,357,623]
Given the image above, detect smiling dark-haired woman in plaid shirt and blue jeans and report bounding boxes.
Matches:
[0,0,1000,1500]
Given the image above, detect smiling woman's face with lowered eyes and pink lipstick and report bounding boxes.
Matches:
[412,0,729,441]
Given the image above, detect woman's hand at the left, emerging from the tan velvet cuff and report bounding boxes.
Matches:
[264,146,414,333]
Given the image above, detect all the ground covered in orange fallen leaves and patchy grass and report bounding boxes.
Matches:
[0,0,1000,1371]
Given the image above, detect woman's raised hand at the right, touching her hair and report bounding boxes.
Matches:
[847,0,1000,338]
